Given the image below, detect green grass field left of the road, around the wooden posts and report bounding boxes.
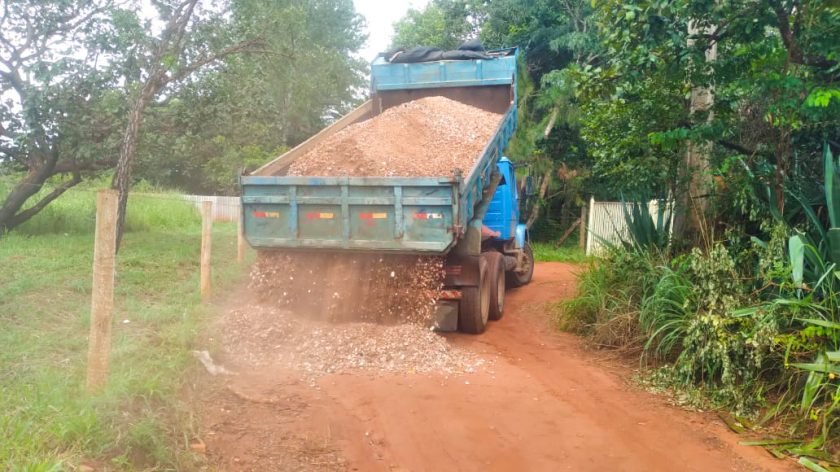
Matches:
[0,191,251,471]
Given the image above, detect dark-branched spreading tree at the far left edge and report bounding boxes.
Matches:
[0,0,125,234]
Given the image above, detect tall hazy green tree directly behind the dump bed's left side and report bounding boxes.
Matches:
[134,0,367,195]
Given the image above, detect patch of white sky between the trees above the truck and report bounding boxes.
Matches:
[353,0,429,62]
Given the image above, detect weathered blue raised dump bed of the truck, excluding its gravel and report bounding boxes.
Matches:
[241,50,516,254]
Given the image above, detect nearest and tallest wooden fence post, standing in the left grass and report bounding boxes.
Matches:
[85,189,118,393]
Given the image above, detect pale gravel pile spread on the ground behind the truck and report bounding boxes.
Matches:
[222,304,485,381]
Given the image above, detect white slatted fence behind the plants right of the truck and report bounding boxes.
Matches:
[586,198,674,255]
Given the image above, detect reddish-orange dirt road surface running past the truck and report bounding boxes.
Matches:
[199,263,797,471]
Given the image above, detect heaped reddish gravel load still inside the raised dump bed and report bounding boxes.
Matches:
[289,97,502,177]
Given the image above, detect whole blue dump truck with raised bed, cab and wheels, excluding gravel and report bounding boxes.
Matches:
[240,49,534,334]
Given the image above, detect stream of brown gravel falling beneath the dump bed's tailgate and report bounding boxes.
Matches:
[250,252,444,325]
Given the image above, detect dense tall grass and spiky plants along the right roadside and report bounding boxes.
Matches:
[560,146,840,463]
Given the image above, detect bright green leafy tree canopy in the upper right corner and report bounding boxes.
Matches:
[585,0,840,240]
